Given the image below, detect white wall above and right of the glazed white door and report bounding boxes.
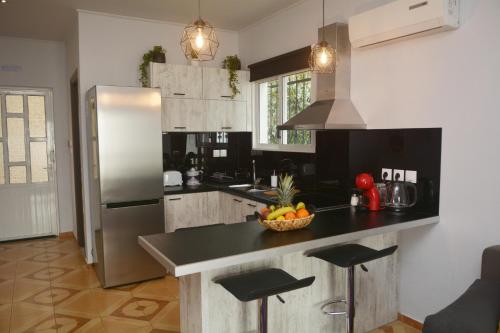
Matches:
[0,37,74,232]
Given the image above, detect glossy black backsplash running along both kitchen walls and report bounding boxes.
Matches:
[163,128,442,209]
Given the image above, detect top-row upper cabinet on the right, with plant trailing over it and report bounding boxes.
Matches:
[203,67,249,101]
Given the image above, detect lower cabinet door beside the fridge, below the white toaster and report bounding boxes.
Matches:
[165,193,207,232]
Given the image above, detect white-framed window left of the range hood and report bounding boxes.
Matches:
[254,71,315,152]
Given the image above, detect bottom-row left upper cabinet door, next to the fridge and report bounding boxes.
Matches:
[162,98,205,132]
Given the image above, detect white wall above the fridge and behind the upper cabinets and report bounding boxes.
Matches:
[78,11,238,259]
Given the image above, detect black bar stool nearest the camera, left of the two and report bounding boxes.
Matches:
[214,268,315,333]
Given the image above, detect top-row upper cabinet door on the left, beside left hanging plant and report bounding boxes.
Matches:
[150,63,203,99]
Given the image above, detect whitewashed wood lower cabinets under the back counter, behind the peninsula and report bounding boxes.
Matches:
[165,192,266,232]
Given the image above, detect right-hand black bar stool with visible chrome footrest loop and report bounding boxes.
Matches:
[307,244,398,333]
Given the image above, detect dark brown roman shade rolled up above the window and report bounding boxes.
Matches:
[248,46,311,82]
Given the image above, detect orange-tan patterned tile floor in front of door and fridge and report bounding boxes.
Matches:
[0,235,419,333]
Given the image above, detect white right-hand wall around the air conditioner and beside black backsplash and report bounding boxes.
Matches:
[240,0,500,321]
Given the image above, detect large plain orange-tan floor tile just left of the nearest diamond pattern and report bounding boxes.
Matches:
[55,288,131,318]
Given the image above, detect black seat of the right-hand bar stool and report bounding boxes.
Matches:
[308,244,398,267]
